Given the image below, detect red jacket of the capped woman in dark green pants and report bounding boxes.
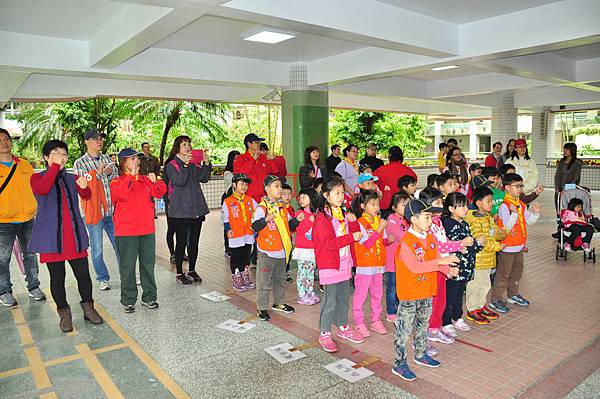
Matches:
[110,175,167,236]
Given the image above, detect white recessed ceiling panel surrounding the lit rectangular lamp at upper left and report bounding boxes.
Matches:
[154,15,364,62]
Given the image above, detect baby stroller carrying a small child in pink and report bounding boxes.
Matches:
[556,186,598,263]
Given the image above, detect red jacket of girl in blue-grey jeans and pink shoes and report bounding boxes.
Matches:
[312,212,354,269]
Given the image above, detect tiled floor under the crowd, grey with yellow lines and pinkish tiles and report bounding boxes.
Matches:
[0,193,600,399]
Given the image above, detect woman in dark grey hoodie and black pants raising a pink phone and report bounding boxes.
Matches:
[165,136,212,285]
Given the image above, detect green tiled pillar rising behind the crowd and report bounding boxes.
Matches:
[281,90,329,188]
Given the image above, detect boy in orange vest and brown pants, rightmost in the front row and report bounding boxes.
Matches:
[490,173,540,313]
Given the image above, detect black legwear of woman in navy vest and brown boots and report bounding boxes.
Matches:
[48,257,92,309]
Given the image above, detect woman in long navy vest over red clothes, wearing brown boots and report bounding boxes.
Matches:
[29,140,102,332]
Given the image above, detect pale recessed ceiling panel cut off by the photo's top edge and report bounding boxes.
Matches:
[377,0,559,24]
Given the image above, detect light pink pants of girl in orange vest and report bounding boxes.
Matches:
[352,274,382,325]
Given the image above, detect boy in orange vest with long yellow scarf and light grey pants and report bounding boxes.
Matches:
[252,175,304,321]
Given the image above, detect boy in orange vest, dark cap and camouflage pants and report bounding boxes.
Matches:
[392,199,459,381]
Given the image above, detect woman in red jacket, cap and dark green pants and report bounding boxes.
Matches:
[110,148,167,313]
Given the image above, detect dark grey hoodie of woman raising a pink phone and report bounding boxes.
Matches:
[165,157,212,219]
